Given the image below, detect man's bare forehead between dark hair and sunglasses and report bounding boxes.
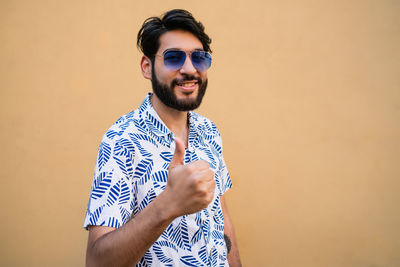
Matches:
[158,30,203,53]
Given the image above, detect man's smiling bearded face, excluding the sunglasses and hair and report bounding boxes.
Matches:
[152,30,207,111]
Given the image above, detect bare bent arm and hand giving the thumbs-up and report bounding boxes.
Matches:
[86,139,215,267]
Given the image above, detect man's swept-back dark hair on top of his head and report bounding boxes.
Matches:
[137,9,212,60]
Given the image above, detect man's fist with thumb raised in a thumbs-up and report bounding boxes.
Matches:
[164,138,215,217]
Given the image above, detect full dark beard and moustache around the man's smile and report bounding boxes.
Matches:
[151,64,208,111]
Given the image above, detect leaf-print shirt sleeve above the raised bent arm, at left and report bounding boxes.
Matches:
[84,133,135,229]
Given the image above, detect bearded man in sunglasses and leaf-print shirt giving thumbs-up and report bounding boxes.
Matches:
[84,10,241,266]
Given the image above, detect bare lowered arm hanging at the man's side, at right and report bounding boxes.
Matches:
[220,196,242,267]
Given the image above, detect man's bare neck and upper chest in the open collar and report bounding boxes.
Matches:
[150,94,189,147]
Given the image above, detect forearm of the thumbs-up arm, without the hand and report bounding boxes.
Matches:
[86,194,175,267]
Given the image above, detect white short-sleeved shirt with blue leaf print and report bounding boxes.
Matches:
[84,94,232,266]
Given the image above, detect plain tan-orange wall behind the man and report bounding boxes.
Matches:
[0,0,400,267]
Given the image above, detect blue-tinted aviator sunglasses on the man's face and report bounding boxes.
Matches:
[158,50,211,71]
